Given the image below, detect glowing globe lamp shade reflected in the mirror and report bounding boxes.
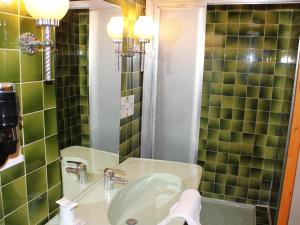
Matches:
[106,16,124,40]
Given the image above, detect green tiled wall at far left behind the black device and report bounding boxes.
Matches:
[0,0,62,225]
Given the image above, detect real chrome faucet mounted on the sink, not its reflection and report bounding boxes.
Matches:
[104,168,128,190]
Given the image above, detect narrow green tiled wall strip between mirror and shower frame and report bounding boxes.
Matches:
[119,1,145,162]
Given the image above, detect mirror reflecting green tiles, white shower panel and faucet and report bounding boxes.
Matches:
[56,0,121,199]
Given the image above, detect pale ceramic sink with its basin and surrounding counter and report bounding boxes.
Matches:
[48,158,202,225]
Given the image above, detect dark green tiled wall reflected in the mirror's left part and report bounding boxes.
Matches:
[56,10,89,149]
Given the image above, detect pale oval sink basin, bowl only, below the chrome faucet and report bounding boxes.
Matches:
[108,173,185,225]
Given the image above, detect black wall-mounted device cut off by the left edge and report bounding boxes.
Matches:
[0,83,20,167]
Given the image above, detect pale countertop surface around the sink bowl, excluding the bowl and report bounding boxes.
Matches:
[47,158,202,225]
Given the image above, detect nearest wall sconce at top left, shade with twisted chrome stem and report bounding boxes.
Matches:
[20,0,69,81]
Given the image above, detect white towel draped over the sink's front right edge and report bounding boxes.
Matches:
[158,189,201,225]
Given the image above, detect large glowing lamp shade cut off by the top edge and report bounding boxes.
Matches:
[24,0,69,20]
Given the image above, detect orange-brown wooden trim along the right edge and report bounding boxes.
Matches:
[277,62,300,225]
